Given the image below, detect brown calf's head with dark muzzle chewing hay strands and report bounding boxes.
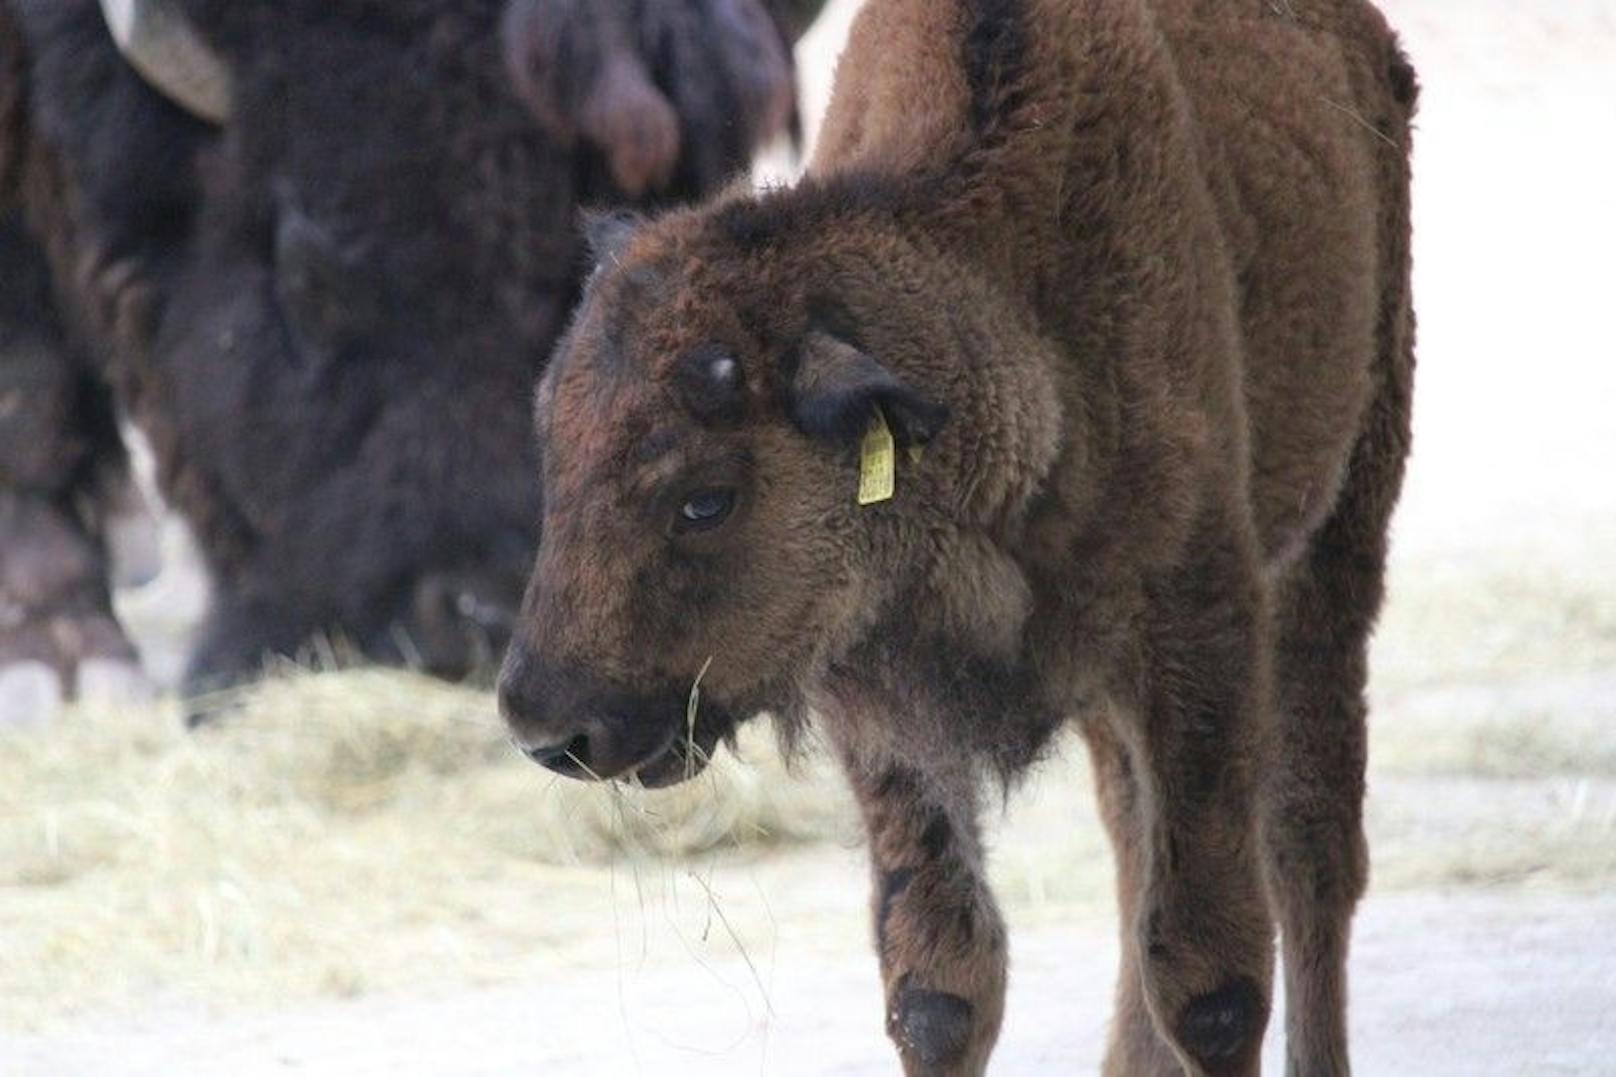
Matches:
[501,213,949,786]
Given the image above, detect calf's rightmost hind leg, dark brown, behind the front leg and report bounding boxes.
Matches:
[1264,360,1409,1077]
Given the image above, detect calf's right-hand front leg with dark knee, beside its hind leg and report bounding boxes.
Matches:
[1109,527,1273,1074]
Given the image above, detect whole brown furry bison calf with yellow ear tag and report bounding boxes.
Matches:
[503,0,1414,1075]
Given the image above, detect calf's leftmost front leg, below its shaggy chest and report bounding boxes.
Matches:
[848,747,1005,1077]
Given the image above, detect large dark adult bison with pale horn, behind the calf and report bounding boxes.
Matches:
[0,0,813,711]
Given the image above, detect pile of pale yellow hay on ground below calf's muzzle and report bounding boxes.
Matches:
[0,669,853,1024]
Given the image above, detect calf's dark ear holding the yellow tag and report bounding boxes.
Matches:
[790,330,949,446]
